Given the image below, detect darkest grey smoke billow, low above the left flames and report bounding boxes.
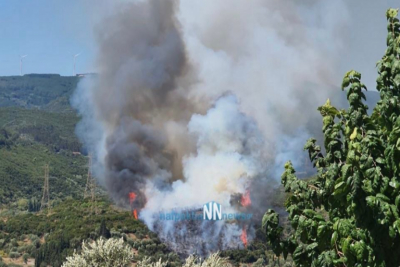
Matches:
[105,118,171,208]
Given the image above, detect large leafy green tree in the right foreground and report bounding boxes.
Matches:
[262,9,400,267]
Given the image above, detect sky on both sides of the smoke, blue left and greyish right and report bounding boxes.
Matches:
[0,0,400,89]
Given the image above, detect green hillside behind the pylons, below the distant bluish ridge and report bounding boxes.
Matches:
[0,105,87,206]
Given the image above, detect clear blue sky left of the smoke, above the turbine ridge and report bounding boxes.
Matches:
[0,0,101,75]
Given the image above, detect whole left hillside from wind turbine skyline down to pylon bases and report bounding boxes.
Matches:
[0,74,87,207]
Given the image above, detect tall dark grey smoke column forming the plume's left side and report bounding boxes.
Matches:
[87,0,195,208]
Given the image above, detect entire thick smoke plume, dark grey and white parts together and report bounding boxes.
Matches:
[73,0,347,255]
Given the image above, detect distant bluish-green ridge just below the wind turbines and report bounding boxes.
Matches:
[0,74,80,112]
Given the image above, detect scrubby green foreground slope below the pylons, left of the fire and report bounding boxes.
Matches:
[0,199,181,267]
